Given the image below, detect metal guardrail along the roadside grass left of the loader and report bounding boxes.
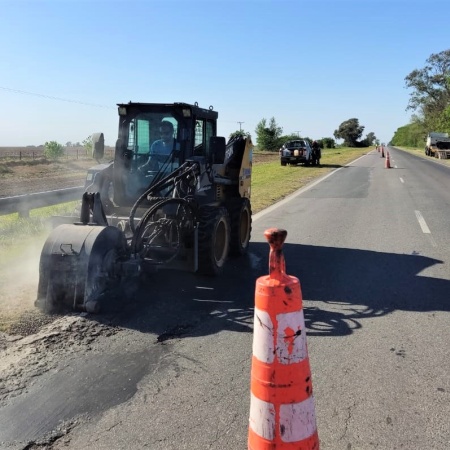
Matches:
[0,186,84,217]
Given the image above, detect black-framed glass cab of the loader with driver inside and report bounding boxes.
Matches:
[113,102,218,206]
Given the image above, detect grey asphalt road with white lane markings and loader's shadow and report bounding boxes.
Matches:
[0,149,450,450]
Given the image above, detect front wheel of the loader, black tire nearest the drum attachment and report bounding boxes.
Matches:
[198,206,231,275]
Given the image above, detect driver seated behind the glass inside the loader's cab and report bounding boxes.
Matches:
[139,120,180,173]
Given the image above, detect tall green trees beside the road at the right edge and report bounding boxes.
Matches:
[391,50,450,147]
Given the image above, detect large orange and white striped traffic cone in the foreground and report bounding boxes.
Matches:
[248,228,319,450]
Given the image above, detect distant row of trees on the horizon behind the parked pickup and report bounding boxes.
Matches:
[230,117,378,152]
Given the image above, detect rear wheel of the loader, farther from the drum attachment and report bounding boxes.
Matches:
[227,197,252,256]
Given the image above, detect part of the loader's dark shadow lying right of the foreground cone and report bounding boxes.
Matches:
[284,244,450,336]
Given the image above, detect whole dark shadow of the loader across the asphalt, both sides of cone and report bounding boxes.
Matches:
[92,243,450,342]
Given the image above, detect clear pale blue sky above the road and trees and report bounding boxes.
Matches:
[0,0,450,147]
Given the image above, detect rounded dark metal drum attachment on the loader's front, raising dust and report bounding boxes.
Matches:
[35,224,126,313]
